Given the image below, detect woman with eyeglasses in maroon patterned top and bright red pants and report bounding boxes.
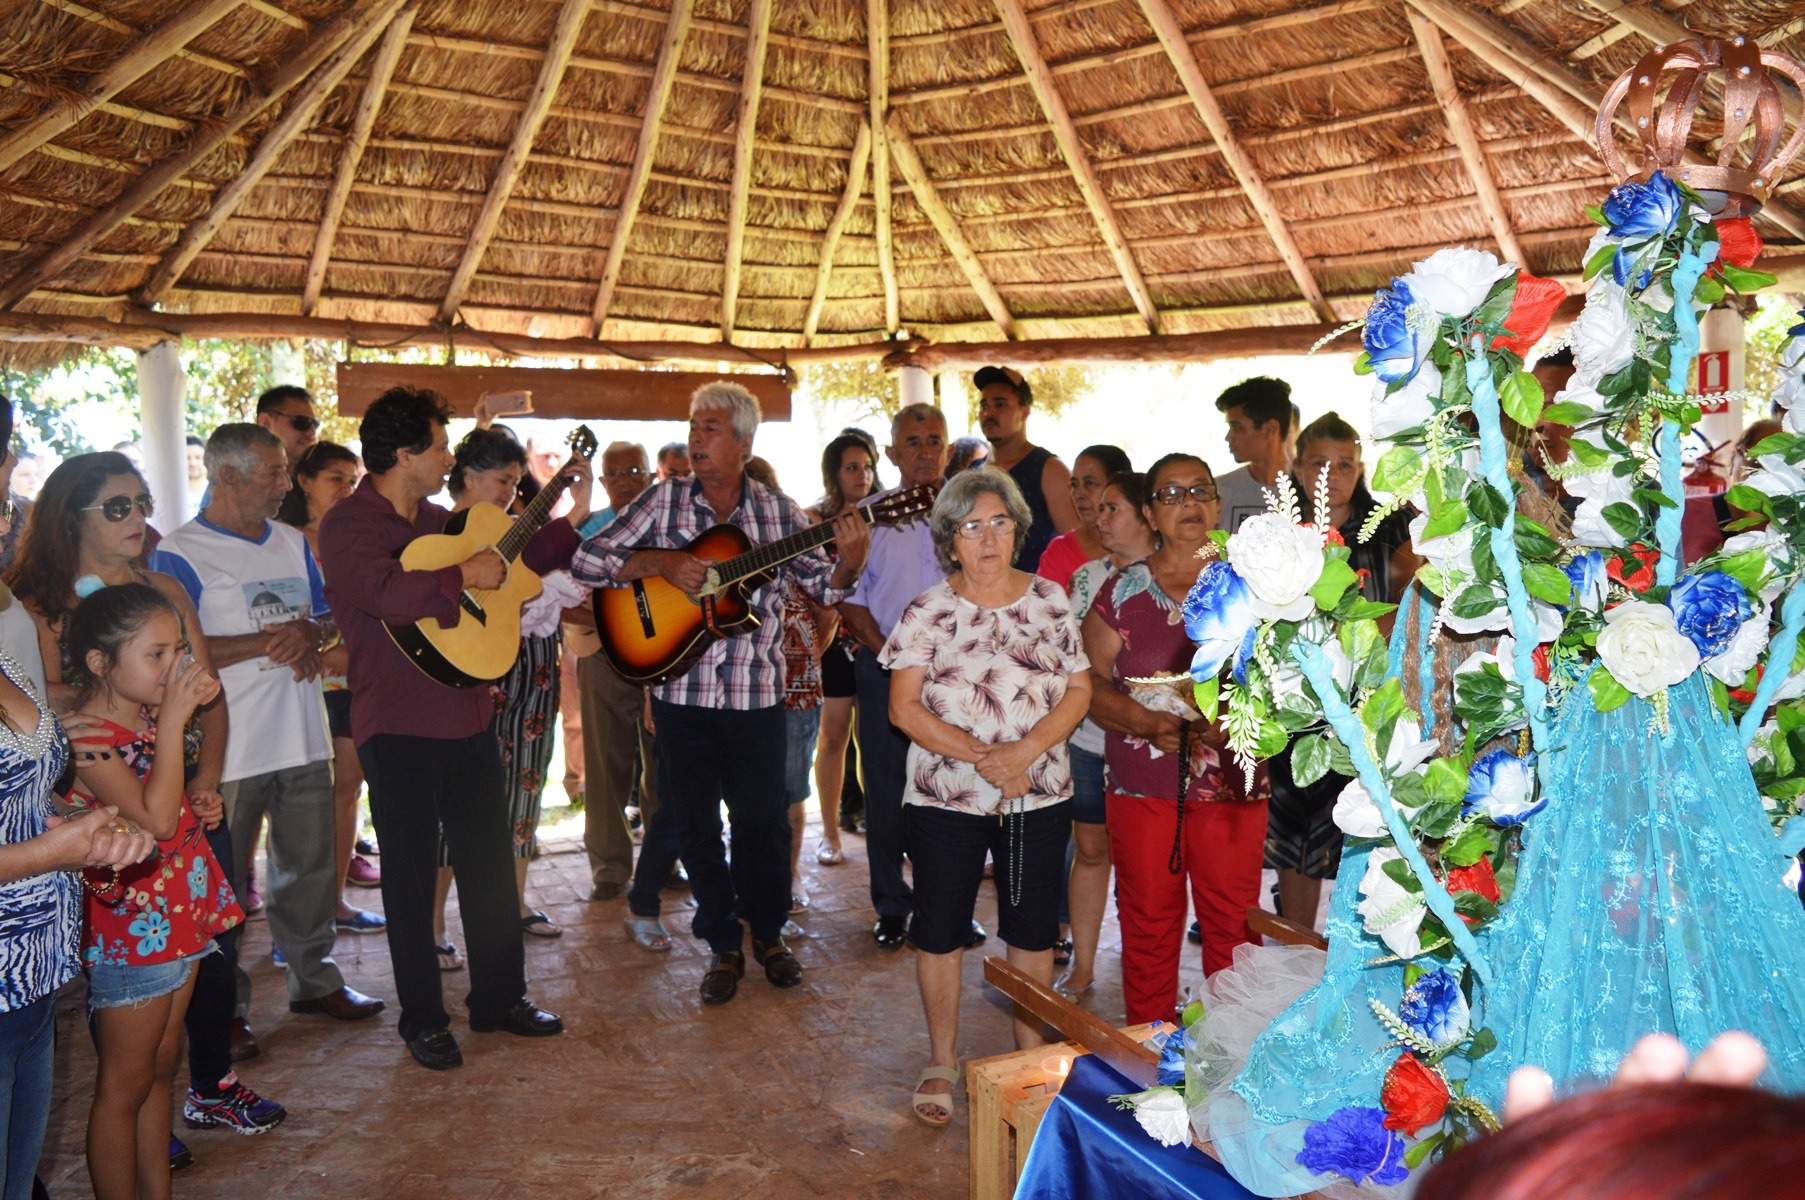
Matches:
[1085,453,1265,1025]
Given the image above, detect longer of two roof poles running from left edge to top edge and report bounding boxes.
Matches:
[0,0,401,309]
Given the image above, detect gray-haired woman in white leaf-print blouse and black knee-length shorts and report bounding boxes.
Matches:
[879,469,1090,1126]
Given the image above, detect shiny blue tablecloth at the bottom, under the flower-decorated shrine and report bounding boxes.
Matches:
[1016,1054,1258,1200]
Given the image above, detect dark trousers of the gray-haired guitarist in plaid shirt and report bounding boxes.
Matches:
[649,698,791,955]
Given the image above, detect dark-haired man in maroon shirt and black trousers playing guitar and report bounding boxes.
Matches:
[319,388,578,1070]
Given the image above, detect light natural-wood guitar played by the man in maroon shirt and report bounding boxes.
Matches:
[388,426,596,688]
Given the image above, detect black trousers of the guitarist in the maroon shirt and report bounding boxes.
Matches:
[357,729,527,1041]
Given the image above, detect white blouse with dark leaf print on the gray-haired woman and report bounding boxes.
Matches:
[879,576,1090,816]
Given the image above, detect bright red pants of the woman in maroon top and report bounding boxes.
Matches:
[1108,792,1265,1025]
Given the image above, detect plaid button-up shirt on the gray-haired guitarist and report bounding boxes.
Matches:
[570,478,847,709]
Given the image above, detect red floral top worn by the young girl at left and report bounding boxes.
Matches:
[69,716,244,967]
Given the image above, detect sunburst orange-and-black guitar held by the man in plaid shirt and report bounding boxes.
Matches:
[594,485,935,684]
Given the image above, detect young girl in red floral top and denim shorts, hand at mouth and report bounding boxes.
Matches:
[67,583,244,1200]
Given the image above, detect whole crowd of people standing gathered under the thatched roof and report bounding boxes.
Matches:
[0,344,1776,1200]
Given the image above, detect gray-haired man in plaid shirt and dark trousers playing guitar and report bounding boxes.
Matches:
[570,383,870,1005]
